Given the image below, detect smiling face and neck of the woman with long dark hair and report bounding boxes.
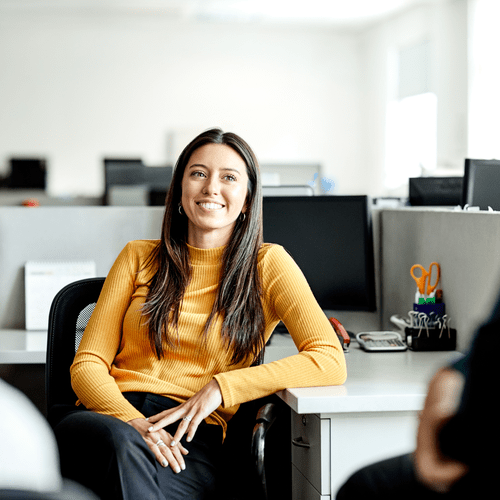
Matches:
[181,144,248,248]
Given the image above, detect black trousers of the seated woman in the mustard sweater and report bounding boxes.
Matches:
[54,392,222,500]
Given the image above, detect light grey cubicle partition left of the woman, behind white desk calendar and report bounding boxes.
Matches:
[0,207,163,329]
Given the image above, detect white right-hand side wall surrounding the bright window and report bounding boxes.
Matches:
[360,0,468,196]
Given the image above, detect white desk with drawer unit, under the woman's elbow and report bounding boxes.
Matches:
[279,343,460,500]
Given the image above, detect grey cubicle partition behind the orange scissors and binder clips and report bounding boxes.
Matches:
[380,208,500,351]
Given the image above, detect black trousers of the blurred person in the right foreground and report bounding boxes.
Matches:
[336,453,476,500]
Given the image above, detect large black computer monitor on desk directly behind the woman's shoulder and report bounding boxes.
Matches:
[263,196,376,311]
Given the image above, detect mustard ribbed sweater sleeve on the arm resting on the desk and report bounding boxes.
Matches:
[215,245,347,408]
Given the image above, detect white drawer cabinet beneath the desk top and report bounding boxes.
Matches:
[292,411,417,500]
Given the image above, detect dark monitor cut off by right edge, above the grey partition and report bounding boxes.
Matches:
[462,158,500,210]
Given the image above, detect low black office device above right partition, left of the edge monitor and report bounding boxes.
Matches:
[409,177,463,206]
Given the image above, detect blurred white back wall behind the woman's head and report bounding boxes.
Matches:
[0,13,367,195]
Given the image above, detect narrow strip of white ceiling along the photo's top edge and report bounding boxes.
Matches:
[0,0,444,27]
